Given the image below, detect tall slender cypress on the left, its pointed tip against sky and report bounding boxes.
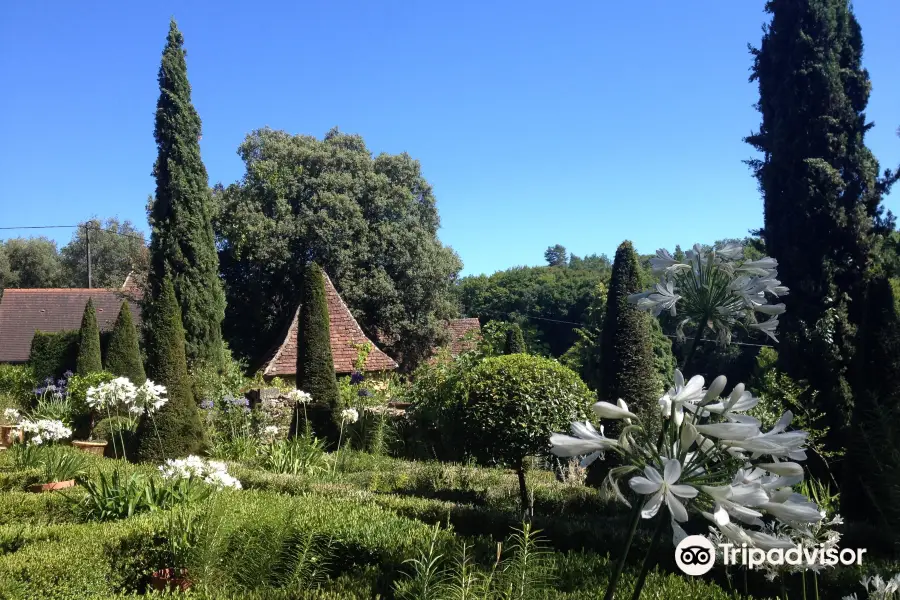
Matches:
[147,20,225,364]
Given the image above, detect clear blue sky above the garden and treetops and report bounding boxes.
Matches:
[0,0,900,274]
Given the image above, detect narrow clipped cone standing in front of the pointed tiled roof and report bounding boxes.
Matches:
[297,263,340,408]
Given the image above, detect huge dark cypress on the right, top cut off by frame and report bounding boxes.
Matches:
[747,0,883,447]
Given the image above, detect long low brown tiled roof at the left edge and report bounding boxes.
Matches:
[0,288,141,363]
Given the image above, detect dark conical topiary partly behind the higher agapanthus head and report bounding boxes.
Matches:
[598,241,659,422]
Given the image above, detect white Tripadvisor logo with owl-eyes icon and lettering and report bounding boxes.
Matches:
[675,535,866,575]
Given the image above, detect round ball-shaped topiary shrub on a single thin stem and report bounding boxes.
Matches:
[462,354,594,514]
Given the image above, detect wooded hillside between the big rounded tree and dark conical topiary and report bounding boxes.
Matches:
[456,256,610,356]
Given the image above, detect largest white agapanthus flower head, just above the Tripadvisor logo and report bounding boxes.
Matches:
[550,371,823,550]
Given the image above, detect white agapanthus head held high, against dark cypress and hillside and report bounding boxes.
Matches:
[628,244,788,344]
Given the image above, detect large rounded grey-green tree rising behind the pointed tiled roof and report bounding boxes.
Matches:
[216,129,462,368]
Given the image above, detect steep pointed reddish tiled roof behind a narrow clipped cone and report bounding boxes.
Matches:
[262,275,397,377]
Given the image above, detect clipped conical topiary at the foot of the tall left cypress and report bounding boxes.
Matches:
[134,277,203,462]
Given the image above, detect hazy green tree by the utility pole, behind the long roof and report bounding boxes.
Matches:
[59,217,148,288]
